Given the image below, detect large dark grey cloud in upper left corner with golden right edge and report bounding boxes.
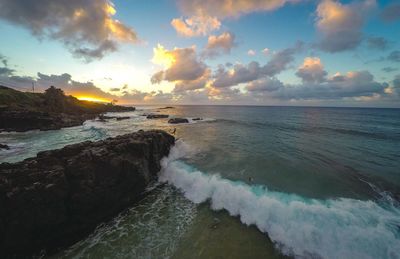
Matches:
[0,0,138,61]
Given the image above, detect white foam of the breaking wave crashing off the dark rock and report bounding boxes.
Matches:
[160,141,400,258]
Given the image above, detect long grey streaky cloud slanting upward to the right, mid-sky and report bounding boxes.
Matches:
[212,43,303,88]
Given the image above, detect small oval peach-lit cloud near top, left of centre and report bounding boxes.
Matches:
[171,15,221,37]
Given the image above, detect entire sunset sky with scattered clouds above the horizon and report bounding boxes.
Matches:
[0,0,400,108]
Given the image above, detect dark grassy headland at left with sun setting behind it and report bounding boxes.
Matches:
[0,85,135,132]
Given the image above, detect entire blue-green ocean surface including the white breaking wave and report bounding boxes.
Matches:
[0,106,400,258]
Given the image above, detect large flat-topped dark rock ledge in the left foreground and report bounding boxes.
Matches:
[0,131,175,258]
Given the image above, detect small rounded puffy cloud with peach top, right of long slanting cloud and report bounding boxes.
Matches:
[296,57,328,84]
